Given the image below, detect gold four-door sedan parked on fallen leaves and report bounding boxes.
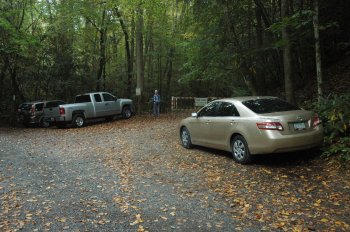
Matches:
[180,96,323,164]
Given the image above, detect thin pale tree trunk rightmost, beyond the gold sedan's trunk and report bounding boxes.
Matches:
[313,0,323,102]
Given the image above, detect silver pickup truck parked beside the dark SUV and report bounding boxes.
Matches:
[47,92,133,127]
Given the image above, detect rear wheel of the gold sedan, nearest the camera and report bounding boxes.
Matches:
[231,135,252,164]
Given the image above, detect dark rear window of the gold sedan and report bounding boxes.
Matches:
[242,98,300,114]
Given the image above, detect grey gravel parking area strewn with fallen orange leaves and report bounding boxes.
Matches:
[0,115,350,231]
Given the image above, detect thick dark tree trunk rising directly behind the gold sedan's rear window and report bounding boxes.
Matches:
[281,0,295,104]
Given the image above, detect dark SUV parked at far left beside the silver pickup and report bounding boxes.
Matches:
[17,100,66,127]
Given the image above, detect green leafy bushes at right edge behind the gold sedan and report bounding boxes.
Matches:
[316,93,350,162]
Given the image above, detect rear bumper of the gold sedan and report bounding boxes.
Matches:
[248,127,323,155]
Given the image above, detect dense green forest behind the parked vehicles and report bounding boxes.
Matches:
[0,0,350,159]
